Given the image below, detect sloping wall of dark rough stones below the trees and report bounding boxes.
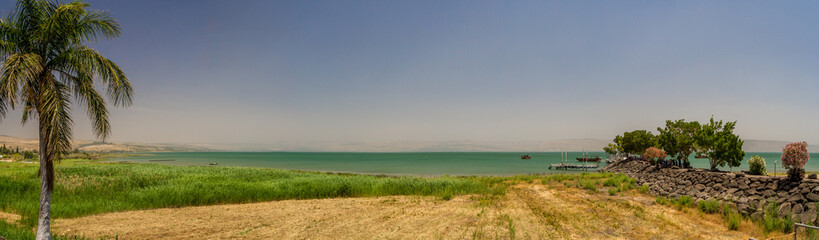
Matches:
[601,160,819,224]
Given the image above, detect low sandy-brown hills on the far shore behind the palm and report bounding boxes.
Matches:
[0,135,210,153]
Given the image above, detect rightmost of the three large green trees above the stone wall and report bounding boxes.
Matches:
[694,117,745,171]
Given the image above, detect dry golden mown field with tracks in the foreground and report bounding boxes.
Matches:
[46,184,768,239]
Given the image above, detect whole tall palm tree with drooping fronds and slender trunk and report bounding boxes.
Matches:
[0,0,133,239]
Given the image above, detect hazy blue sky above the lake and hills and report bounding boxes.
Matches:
[0,0,819,148]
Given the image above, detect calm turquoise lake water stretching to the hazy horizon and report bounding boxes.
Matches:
[112,152,819,176]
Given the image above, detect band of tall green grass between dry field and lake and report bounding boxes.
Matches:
[0,161,494,229]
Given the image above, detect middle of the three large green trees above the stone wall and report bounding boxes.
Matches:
[657,119,701,166]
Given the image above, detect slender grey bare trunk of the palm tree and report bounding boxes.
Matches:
[36,122,54,240]
